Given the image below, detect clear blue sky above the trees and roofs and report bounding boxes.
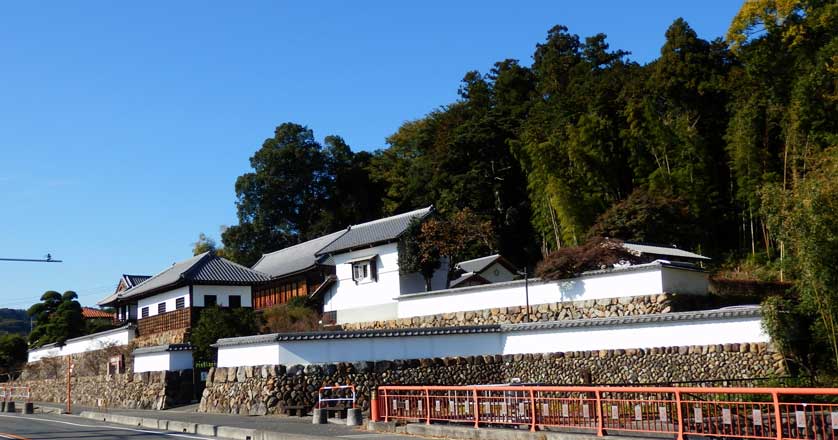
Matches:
[0,0,741,308]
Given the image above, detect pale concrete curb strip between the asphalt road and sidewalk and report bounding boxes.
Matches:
[79,411,348,440]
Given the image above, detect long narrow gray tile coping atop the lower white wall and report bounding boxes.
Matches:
[213,305,761,347]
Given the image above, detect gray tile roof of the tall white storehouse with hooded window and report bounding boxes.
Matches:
[317,206,433,255]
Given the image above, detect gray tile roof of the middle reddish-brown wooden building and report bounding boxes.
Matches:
[253,229,346,278]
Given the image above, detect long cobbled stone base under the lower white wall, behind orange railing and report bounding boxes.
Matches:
[198,343,785,415]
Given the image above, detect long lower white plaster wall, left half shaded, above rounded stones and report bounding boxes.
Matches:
[218,315,769,367]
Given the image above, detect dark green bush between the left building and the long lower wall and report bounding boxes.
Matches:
[190,306,259,361]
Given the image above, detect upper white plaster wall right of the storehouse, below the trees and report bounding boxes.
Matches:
[398,262,708,319]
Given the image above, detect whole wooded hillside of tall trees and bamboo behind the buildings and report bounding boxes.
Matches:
[202,0,838,382]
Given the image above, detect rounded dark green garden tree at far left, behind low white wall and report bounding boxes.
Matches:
[27,290,85,348]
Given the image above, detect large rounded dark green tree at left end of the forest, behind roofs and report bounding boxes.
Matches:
[220,123,381,266]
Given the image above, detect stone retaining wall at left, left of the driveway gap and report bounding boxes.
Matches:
[14,370,192,410]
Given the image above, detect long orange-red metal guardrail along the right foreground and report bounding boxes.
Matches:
[371,385,838,440]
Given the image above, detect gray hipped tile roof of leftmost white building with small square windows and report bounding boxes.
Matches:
[99,252,270,305]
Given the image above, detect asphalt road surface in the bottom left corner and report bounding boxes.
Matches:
[0,414,212,440]
